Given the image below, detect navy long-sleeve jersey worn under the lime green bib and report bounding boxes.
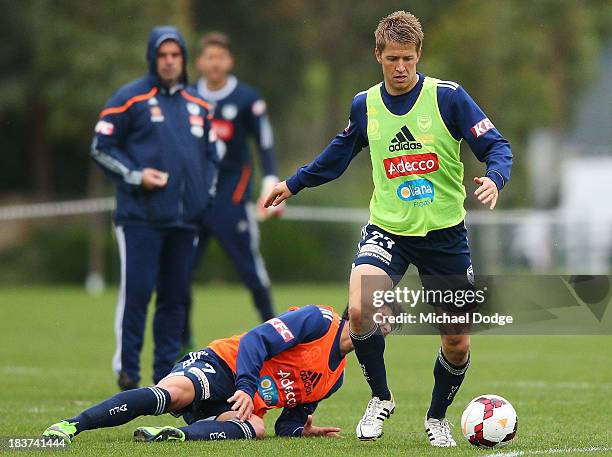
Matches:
[287,73,512,194]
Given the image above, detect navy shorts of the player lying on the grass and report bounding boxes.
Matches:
[166,348,236,424]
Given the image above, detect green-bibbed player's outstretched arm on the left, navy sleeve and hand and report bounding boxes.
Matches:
[264,93,368,207]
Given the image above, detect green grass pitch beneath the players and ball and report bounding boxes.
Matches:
[0,284,612,457]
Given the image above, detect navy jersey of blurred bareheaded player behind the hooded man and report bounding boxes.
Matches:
[195,75,277,204]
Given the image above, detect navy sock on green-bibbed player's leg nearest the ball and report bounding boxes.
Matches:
[427,348,470,419]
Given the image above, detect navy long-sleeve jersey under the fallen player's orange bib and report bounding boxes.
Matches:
[236,305,345,436]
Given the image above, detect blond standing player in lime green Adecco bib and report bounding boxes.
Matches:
[266,11,512,447]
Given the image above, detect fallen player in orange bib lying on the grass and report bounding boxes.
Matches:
[43,304,399,443]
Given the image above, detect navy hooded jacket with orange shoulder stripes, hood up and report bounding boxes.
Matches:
[91,26,219,228]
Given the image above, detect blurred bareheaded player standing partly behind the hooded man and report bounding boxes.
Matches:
[183,32,283,347]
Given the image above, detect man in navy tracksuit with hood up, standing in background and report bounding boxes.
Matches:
[91,27,219,390]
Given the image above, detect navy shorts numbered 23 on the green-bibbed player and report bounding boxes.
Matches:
[353,222,474,311]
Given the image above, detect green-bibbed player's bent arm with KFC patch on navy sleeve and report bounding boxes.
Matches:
[440,86,512,209]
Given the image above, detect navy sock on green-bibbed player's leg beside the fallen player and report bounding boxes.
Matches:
[350,324,391,400]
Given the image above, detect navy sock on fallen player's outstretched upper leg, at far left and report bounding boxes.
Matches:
[66,387,170,433]
